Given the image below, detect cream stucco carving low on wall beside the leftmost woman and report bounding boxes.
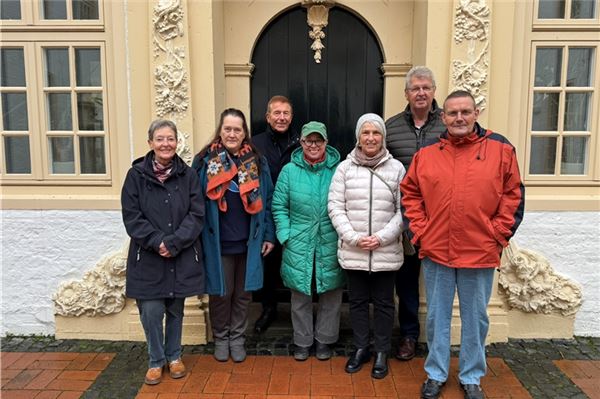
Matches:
[52,245,128,316]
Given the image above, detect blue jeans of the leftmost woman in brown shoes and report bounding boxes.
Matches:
[136,298,185,368]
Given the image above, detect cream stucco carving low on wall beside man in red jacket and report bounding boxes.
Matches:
[498,240,582,316]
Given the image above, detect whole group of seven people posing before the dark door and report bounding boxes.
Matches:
[122,67,524,399]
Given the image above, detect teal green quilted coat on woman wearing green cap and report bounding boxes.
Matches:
[272,146,345,295]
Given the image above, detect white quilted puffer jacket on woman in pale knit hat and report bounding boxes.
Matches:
[328,150,405,272]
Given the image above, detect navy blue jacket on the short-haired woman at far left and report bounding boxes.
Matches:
[121,151,204,299]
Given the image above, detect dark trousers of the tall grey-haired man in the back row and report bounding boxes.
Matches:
[396,252,421,341]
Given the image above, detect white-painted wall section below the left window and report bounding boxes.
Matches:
[0,210,127,336]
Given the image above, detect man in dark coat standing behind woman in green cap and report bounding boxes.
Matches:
[252,96,300,333]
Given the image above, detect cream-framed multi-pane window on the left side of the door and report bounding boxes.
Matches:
[0,0,110,182]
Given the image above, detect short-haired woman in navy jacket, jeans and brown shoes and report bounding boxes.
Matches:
[121,120,204,385]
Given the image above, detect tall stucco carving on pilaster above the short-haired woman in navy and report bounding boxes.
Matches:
[152,0,192,164]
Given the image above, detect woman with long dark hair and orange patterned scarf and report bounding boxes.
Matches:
[192,108,275,362]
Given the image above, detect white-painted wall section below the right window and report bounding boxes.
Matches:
[515,211,600,337]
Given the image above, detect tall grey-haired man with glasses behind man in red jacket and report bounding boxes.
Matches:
[385,66,445,360]
